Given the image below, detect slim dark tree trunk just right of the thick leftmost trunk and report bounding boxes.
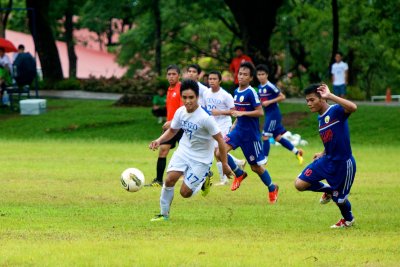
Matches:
[65,0,77,78]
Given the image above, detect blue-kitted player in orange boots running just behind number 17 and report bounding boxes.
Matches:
[216,62,279,204]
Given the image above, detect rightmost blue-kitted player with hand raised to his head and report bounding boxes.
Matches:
[295,84,357,228]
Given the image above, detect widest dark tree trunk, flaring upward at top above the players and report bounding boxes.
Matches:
[225,0,283,66]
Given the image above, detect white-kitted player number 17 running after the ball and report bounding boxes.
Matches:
[149,80,232,221]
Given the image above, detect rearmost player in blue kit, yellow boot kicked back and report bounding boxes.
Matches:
[256,64,303,165]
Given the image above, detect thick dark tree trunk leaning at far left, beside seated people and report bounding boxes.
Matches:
[26,0,63,82]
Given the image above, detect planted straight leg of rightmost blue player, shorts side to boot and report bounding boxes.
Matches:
[331,157,356,228]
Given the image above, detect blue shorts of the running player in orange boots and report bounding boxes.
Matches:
[225,130,267,165]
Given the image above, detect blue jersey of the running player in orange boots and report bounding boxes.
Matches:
[233,86,261,141]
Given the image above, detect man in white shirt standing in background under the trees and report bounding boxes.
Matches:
[331,52,349,98]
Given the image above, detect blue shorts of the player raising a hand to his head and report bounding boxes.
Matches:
[298,156,356,203]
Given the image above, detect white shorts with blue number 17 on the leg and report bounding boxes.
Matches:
[167,153,212,191]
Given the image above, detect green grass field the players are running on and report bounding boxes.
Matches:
[0,100,400,266]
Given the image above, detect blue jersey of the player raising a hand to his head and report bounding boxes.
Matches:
[318,104,352,160]
